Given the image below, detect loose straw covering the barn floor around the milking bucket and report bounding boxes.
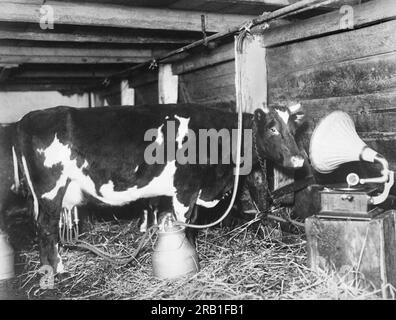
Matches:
[11,220,392,300]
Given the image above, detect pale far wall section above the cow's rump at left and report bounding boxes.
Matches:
[0,91,88,123]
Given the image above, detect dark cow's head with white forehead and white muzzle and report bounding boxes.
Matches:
[254,104,304,169]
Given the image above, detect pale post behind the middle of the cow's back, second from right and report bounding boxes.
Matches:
[158,64,179,104]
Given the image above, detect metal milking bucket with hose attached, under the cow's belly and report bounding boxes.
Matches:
[152,214,199,279]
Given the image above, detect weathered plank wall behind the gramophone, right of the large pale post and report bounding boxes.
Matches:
[267,20,396,182]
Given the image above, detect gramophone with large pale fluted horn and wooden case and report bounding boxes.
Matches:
[310,111,394,219]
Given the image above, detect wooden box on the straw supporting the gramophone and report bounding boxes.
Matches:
[305,210,396,295]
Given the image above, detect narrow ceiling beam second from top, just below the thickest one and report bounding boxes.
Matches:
[0,29,199,45]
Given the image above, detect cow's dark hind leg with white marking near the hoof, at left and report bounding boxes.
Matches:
[37,200,65,273]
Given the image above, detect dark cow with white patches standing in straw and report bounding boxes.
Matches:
[13,104,304,273]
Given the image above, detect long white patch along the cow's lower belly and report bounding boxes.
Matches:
[97,160,176,205]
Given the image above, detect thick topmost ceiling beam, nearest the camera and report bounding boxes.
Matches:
[0,0,253,32]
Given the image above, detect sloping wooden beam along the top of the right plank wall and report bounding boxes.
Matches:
[257,0,396,47]
